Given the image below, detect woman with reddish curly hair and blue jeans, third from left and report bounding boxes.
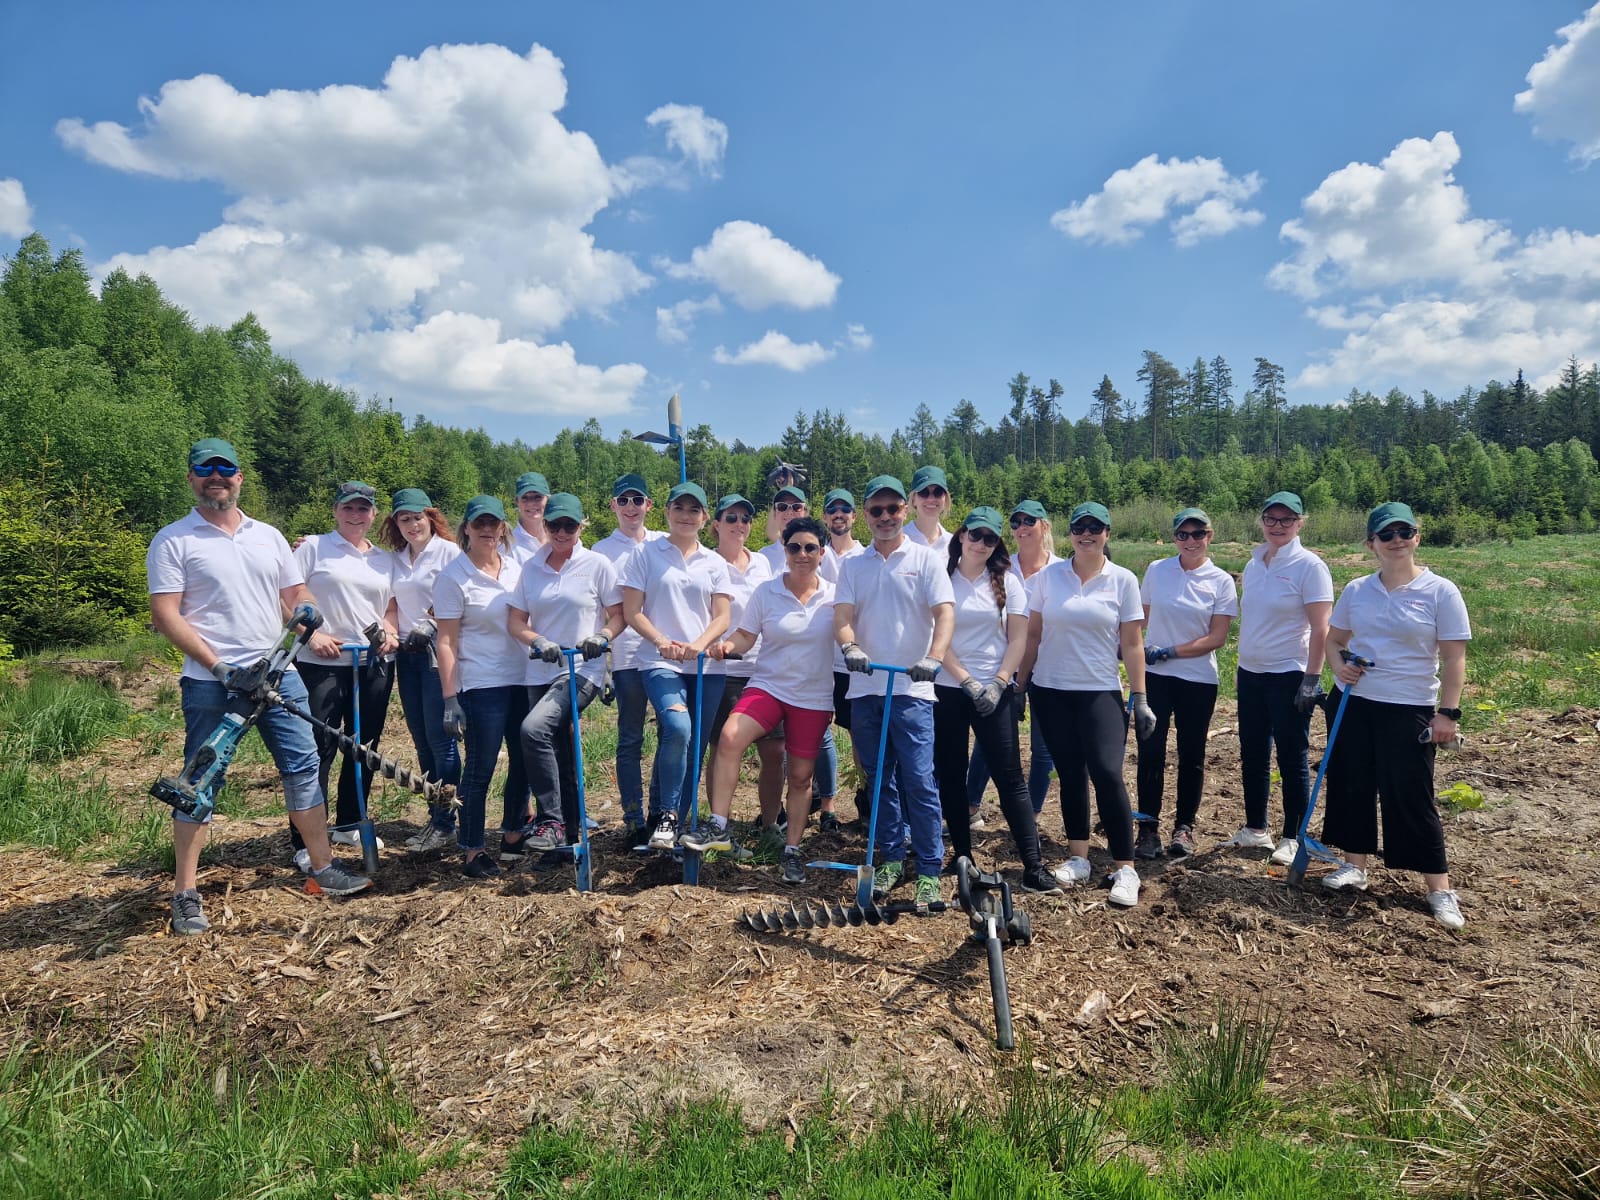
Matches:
[378,488,461,851]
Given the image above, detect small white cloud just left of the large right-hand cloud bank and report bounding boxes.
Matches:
[1050,154,1262,246]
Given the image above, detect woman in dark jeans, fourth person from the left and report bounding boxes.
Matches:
[434,496,531,878]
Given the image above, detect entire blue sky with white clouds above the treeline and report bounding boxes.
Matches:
[0,0,1600,443]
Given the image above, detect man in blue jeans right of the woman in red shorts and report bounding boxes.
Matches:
[834,475,955,904]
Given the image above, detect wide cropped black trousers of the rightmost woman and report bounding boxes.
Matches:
[1322,691,1450,875]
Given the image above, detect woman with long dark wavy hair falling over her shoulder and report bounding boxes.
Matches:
[933,506,1059,893]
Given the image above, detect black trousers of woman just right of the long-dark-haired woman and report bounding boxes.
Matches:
[1024,683,1133,862]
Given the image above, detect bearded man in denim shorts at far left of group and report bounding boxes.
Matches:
[146,437,371,934]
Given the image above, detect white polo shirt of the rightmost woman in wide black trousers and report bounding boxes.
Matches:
[1330,566,1472,704]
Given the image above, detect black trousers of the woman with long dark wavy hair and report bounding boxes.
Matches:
[933,686,1040,869]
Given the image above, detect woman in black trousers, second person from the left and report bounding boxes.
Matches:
[290,480,398,867]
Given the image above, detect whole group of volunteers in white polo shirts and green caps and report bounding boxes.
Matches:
[147,438,1470,933]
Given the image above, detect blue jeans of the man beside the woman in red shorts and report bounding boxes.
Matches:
[850,696,944,875]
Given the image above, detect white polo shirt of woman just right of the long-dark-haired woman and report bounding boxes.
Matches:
[1027,558,1144,693]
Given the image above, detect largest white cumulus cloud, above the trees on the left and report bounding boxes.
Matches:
[56,45,651,413]
